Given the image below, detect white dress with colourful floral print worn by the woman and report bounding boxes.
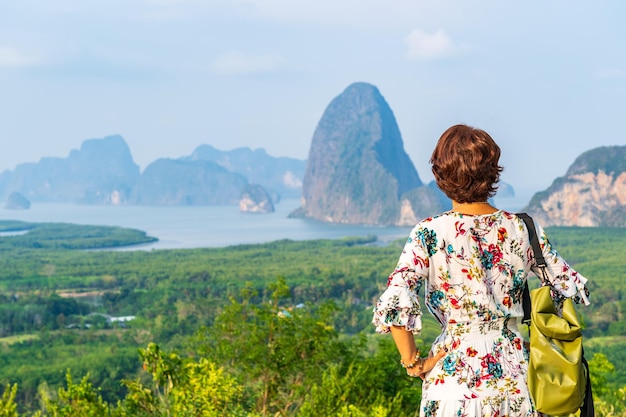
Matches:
[373,210,589,417]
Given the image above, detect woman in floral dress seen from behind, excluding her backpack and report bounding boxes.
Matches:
[373,125,589,417]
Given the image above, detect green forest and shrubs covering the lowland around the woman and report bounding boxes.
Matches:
[0,219,626,417]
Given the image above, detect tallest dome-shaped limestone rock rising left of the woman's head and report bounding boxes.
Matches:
[291,83,445,225]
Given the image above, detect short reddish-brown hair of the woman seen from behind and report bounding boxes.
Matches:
[430,125,502,203]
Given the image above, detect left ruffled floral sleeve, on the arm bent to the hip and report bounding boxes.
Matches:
[372,227,429,334]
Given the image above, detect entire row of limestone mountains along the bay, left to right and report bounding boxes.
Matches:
[0,83,626,227]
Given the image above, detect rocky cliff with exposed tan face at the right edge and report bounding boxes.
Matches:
[524,146,626,227]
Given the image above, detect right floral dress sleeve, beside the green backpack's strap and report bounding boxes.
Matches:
[532,224,589,305]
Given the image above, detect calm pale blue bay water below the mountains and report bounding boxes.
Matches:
[0,199,528,250]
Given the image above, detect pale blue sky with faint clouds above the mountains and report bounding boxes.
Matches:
[0,0,626,197]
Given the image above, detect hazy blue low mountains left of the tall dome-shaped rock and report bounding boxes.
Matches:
[0,135,306,211]
